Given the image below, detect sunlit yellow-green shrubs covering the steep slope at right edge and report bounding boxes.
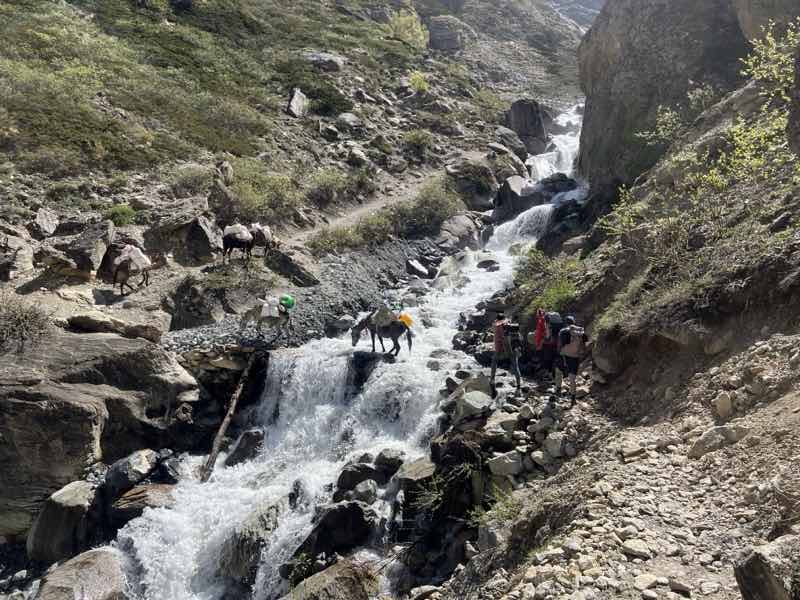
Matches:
[598,19,800,338]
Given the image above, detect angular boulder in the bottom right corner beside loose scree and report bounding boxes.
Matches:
[734,535,800,600]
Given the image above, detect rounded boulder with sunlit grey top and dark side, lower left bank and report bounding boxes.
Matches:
[27,481,97,563]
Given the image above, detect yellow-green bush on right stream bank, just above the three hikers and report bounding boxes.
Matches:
[514,248,581,314]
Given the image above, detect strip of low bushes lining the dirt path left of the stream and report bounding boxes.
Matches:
[306,181,464,256]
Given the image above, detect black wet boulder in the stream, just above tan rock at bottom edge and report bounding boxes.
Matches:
[295,502,378,557]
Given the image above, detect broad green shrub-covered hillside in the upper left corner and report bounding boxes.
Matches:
[0,0,420,178]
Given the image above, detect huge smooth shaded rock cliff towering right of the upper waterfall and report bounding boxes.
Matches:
[579,0,749,184]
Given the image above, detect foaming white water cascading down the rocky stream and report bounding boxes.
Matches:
[117,106,577,600]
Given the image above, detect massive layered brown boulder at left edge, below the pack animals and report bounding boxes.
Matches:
[0,331,199,537]
